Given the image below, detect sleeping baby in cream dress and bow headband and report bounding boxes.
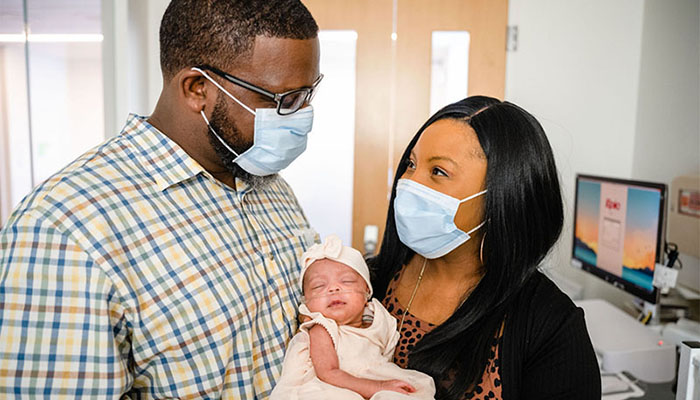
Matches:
[270,236,435,400]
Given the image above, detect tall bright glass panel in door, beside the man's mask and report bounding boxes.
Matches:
[282,31,357,245]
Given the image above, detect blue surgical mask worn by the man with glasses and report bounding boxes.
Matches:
[192,68,314,176]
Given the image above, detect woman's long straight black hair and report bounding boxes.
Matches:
[369,96,564,399]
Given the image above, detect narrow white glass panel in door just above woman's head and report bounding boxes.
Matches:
[430,31,469,115]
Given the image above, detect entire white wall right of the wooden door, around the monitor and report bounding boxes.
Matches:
[506,0,700,306]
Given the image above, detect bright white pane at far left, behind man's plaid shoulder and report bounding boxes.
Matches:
[28,43,104,183]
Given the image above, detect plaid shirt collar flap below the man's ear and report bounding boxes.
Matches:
[121,114,209,191]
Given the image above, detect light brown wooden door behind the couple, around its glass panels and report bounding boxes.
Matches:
[302,0,508,249]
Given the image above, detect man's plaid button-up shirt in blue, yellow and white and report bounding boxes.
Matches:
[0,115,314,399]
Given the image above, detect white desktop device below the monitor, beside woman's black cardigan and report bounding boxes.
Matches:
[576,299,676,383]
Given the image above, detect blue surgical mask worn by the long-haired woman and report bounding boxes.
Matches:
[394,179,486,259]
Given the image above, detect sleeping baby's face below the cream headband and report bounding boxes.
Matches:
[304,258,369,327]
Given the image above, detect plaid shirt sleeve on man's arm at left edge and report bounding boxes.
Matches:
[0,212,133,398]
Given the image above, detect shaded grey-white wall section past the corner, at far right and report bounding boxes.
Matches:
[632,0,700,290]
